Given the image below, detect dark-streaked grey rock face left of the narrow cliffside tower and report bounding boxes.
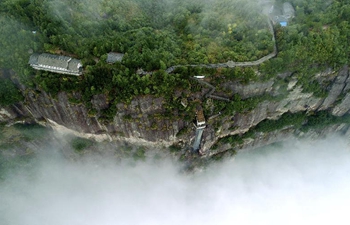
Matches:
[0,91,185,145]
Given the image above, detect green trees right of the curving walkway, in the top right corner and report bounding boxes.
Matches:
[260,0,350,77]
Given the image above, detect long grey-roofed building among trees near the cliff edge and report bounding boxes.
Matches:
[28,53,83,76]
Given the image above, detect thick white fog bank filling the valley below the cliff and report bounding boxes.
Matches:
[0,137,350,225]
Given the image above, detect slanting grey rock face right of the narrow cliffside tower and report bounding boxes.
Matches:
[204,66,350,154]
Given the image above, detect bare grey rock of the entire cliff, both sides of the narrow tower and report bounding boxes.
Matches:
[0,66,350,154]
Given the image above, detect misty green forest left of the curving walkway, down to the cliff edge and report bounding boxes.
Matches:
[0,0,273,109]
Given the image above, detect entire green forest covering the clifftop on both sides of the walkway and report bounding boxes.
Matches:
[0,0,350,120]
